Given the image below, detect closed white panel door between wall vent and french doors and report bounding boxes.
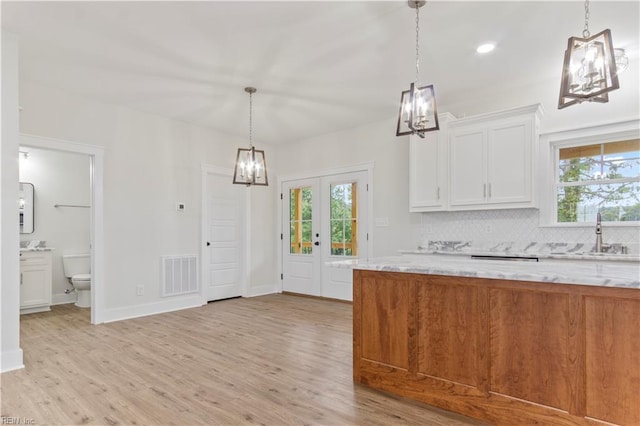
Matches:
[204,173,246,301]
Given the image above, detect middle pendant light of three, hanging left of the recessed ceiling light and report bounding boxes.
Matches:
[396,0,440,138]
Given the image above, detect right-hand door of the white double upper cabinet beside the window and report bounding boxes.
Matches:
[487,121,532,204]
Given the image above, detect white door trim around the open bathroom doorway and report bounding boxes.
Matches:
[20,134,105,324]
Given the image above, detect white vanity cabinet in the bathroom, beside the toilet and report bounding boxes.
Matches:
[20,251,52,314]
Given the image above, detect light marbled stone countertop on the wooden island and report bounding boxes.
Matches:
[329,253,640,289]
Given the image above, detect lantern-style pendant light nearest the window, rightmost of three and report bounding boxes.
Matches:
[558,0,620,109]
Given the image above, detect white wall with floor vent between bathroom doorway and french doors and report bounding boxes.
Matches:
[20,81,277,321]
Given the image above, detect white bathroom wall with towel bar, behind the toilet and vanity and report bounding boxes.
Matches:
[20,147,91,304]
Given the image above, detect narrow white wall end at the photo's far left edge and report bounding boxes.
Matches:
[0,31,23,371]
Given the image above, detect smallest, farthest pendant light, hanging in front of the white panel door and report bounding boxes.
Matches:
[233,87,269,186]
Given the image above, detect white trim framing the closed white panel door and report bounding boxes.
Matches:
[200,164,251,303]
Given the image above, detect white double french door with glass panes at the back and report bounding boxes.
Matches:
[282,171,368,300]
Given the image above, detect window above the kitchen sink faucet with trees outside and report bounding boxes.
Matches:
[554,139,640,223]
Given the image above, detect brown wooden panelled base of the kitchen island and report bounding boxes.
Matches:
[353,270,640,425]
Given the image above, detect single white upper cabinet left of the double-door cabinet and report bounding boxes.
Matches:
[409,113,455,212]
